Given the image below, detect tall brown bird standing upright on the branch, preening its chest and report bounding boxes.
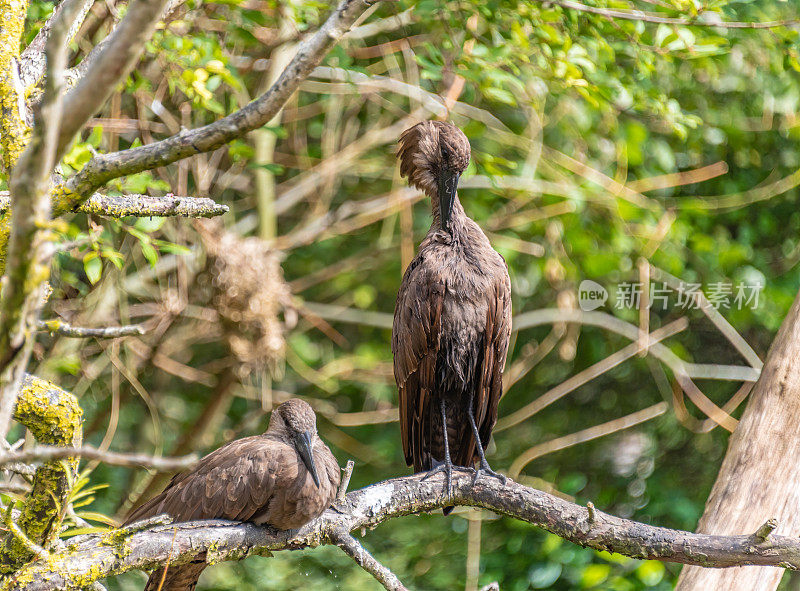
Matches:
[392,121,511,514]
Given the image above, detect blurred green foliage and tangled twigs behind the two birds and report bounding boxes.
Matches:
[6,0,800,591]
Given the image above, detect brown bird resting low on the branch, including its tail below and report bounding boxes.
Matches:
[126,398,340,591]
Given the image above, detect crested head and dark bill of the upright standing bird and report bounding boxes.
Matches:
[397,121,470,231]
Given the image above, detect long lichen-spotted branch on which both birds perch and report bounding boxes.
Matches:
[6,472,800,591]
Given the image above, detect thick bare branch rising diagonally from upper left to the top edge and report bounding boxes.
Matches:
[54,0,382,207]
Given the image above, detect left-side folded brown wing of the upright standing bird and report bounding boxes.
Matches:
[392,254,446,471]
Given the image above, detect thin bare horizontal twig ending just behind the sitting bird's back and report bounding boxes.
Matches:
[0,445,197,472]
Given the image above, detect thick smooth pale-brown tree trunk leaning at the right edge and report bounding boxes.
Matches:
[676,295,800,591]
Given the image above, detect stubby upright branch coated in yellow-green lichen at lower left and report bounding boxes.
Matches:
[0,376,83,573]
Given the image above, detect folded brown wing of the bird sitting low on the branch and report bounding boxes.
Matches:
[126,435,284,523]
